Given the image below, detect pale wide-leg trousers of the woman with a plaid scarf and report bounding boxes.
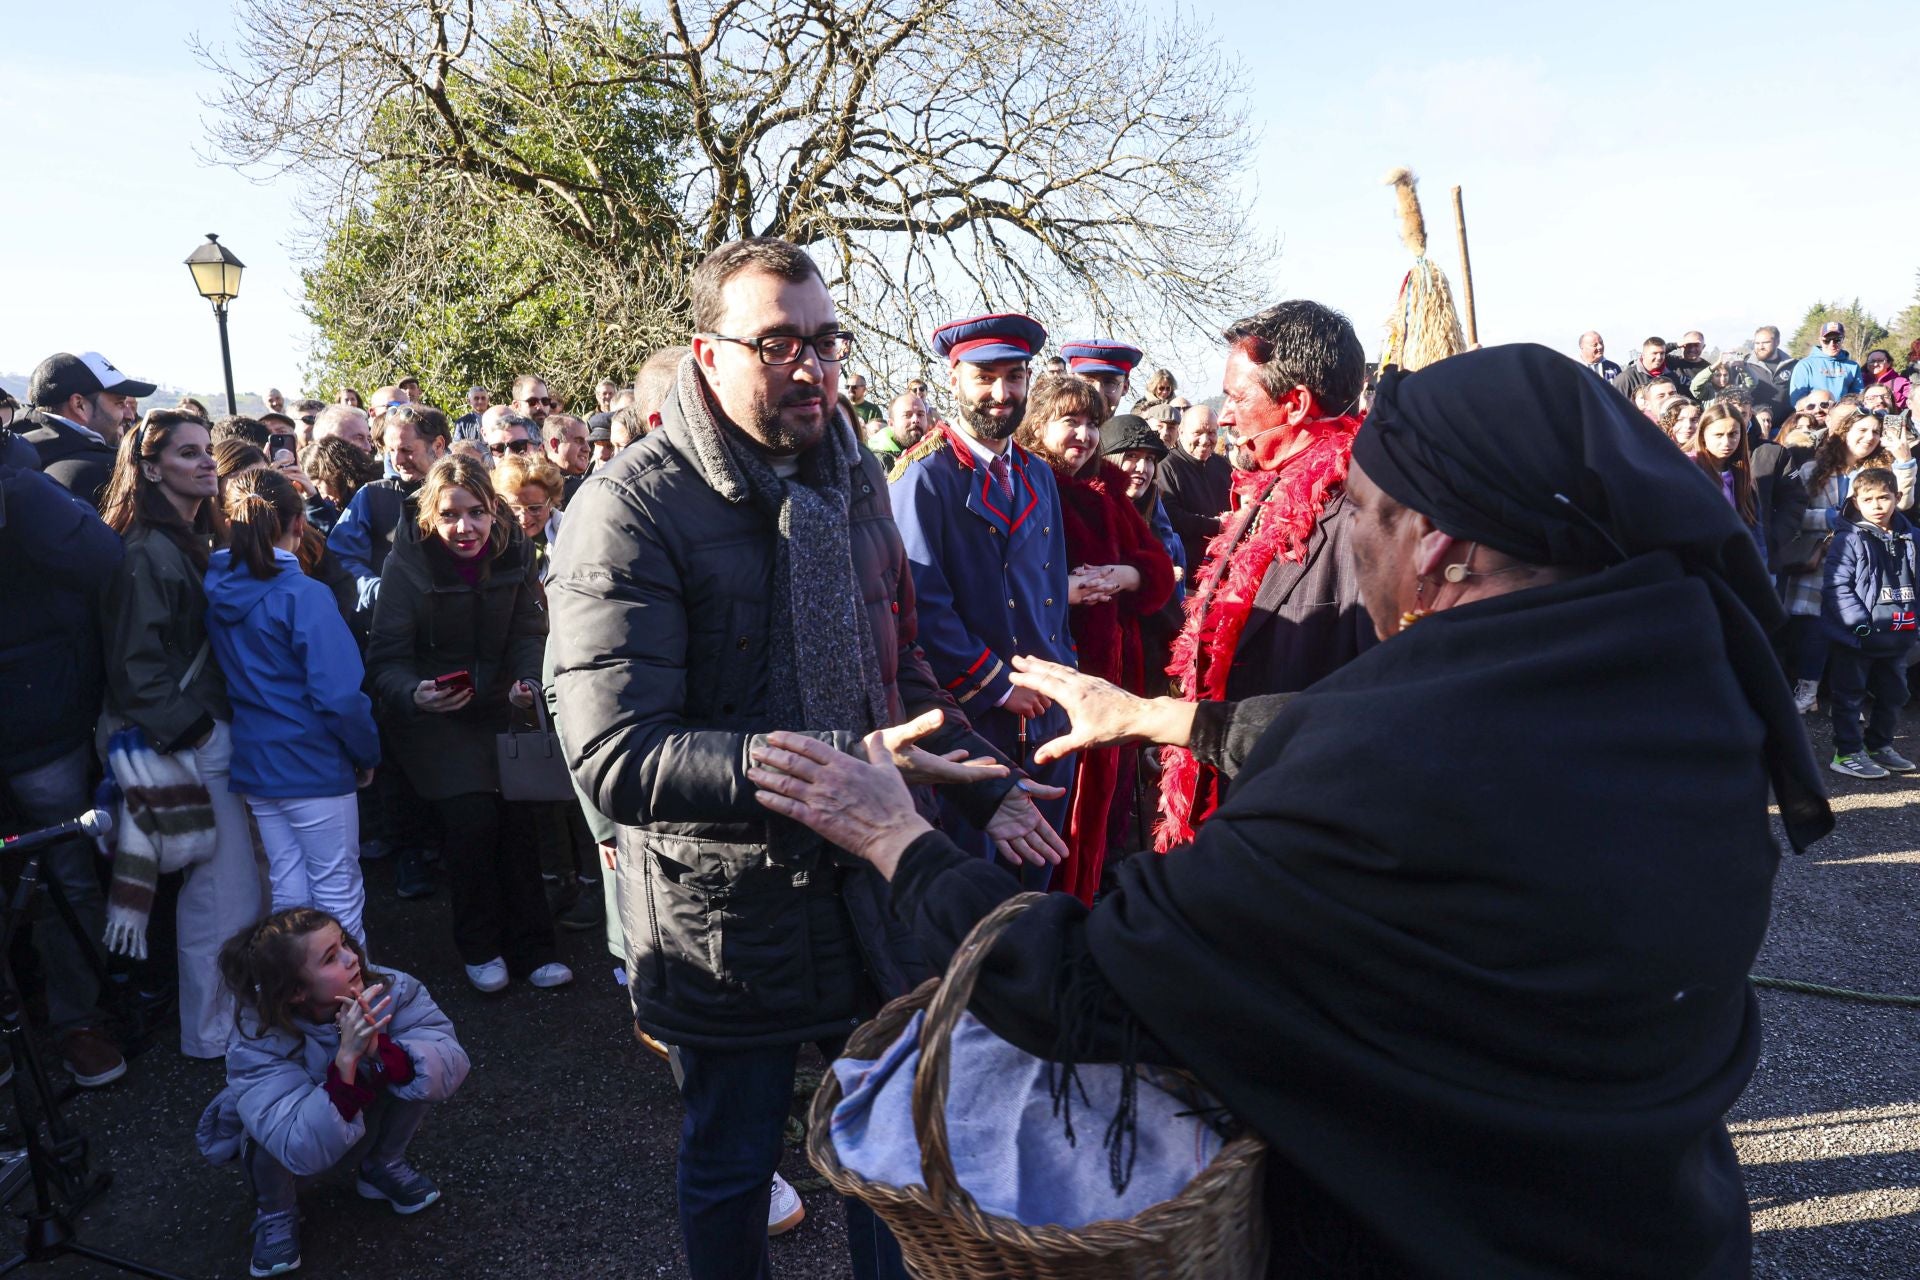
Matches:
[173,720,267,1057]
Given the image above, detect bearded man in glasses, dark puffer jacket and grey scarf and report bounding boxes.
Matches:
[547,240,1064,1280]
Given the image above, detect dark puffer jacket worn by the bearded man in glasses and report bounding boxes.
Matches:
[545,397,1012,1048]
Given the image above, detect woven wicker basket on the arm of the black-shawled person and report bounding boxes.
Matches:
[806,894,1267,1280]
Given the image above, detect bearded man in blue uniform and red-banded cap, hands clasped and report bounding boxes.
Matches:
[891,315,1075,889]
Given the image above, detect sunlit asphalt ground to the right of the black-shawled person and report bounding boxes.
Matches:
[1728,710,1920,1280]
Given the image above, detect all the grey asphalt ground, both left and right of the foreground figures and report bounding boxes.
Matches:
[26,718,1920,1280]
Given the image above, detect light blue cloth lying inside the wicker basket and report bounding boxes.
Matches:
[831,1011,1221,1228]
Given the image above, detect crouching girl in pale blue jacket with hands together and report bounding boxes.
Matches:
[198,905,470,1276]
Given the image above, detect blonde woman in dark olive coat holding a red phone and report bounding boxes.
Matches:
[367,455,574,992]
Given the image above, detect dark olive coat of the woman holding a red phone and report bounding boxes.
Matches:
[367,529,547,800]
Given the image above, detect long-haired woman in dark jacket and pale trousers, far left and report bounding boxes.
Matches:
[99,409,263,1057]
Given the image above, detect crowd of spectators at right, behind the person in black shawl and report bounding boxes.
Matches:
[1580,320,1920,779]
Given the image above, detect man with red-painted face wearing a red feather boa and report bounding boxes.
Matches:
[1154,299,1373,852]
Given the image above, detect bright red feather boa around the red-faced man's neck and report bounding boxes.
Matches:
[1154,416,1359,854]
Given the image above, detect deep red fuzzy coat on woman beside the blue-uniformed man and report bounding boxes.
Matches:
[1052,462,1173,906]
